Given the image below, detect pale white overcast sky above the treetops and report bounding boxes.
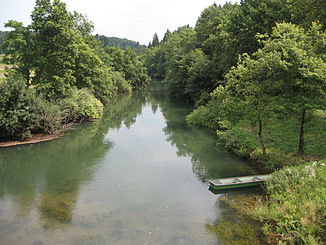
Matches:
[0,0,235,45]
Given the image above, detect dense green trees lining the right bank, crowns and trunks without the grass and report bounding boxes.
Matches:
[145,0,326,158]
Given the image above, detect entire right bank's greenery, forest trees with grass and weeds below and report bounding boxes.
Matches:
[145,0,326,244]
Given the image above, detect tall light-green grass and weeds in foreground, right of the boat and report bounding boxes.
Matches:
[252,159,326,245]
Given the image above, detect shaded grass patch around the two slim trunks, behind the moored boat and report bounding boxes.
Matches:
[217,110,326,170]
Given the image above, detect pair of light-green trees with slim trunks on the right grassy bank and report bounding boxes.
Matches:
[225,23,326,156]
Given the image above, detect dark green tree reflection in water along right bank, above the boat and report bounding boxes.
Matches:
[149,82,253,182]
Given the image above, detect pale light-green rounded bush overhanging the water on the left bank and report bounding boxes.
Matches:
[60,88,103,123]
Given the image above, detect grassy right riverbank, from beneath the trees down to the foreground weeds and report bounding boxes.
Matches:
[187,106,326,244]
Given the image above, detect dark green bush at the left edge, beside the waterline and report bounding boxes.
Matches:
[0,75,38,139]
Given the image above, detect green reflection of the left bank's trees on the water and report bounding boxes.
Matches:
[0,92,145,228]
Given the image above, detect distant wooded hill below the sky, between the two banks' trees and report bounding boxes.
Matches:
[95,34,146,51]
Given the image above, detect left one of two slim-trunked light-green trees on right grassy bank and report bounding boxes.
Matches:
[223,50,285,155]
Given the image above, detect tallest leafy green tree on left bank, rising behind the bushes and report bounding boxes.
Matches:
[31,0,105,98]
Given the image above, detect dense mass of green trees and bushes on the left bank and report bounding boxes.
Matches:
[0,0,149,138]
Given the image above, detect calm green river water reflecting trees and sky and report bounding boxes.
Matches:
[0,82,264,245]
